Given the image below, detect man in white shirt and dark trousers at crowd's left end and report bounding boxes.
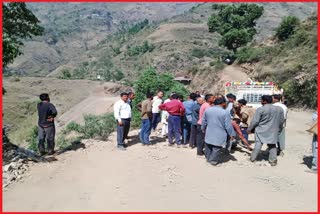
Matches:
[113,93,131,150]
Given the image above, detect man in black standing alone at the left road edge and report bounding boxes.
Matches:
[37,94,58,155]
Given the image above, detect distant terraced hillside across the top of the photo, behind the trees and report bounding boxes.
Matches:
[9,3,316,79]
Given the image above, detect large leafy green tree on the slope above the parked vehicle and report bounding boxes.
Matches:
[207,4,264,53]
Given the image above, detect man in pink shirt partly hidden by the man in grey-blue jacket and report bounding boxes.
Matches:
[196,94,215,157]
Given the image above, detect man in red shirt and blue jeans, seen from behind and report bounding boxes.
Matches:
[159,94,185,147]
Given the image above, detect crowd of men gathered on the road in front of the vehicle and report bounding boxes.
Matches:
[114,90,288,166]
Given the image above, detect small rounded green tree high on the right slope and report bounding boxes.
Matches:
[276,16,300,41]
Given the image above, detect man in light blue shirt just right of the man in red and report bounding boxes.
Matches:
[183,93,197,147]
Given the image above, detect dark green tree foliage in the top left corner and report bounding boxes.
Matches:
[2,2,43,67]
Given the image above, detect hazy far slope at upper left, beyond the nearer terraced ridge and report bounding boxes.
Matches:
[8,3,195,76]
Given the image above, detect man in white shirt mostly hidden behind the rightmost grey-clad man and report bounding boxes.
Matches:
[272,94,288,156]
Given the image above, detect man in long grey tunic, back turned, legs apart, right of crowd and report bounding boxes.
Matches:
[247,95,284,166]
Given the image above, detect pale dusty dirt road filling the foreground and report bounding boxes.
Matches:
[3,111,317,211]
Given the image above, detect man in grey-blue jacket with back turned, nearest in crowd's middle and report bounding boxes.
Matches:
[201,98,234,165]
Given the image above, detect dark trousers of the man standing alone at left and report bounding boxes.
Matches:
[38,126,56,153]
